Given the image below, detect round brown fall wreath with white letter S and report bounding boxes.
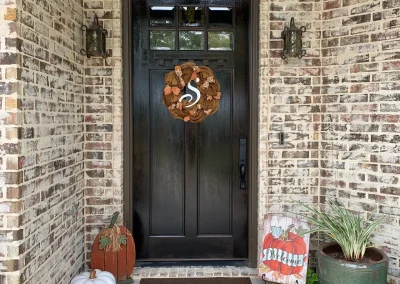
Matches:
[163,62,221,123]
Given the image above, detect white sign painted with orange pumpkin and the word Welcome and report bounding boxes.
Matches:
[258,216,310,284]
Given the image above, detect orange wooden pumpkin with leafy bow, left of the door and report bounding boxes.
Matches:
[91,212,136,281]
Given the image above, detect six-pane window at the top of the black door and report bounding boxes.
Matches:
[149,6,234,51]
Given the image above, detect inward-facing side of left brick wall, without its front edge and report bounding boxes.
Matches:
[18,0,84,283]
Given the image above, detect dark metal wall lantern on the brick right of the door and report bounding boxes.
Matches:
[281,18,306,59]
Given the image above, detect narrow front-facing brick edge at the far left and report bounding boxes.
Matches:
[0,0,22,283]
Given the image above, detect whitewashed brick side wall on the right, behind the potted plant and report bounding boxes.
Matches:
[320,0,400,283]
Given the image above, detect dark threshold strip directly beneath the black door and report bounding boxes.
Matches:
[135,259,248,267]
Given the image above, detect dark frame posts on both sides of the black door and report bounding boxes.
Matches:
[121,0,260,267]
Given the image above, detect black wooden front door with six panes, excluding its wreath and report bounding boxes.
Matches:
[132,0,249,260]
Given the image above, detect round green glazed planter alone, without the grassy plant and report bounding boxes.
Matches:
[317,244,389,284]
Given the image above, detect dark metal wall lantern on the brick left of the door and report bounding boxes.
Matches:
[81,14,109,59]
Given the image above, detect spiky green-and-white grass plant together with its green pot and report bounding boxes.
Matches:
[298,200,389,284]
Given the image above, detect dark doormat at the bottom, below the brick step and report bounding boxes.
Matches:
[140,277,251,284]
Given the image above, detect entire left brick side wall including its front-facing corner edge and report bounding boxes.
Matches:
[0,0,84,283]
